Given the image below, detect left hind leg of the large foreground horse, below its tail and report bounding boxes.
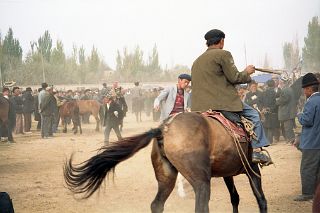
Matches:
[151,141,178,213]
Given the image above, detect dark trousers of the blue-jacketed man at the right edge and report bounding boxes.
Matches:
[300,149,320,195]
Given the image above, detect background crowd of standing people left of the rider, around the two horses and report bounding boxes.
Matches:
[0,82,162,143]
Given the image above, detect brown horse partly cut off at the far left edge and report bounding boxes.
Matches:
[0,97,13,141]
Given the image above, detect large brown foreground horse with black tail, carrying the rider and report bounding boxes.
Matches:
[64,113,267,212]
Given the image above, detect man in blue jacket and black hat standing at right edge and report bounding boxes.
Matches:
[294,73,320,201]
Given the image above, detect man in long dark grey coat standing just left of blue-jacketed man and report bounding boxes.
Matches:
[276,78,297,143]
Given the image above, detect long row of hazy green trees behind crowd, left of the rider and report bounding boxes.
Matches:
[0,28,190,85]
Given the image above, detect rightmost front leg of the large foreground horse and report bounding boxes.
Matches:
[247,163,267,213]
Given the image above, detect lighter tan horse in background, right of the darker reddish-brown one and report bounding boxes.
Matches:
[77,100,101,131]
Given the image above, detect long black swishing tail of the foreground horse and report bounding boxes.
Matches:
[63,128,162,198]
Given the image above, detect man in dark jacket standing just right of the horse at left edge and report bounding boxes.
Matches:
[11,87,24,134]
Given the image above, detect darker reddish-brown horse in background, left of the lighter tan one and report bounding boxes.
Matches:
[59,100,82,134]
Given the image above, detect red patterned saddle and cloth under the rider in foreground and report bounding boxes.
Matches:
[201,110,254,143]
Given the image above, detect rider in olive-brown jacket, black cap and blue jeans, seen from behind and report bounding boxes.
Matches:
[191,29,271,165]
